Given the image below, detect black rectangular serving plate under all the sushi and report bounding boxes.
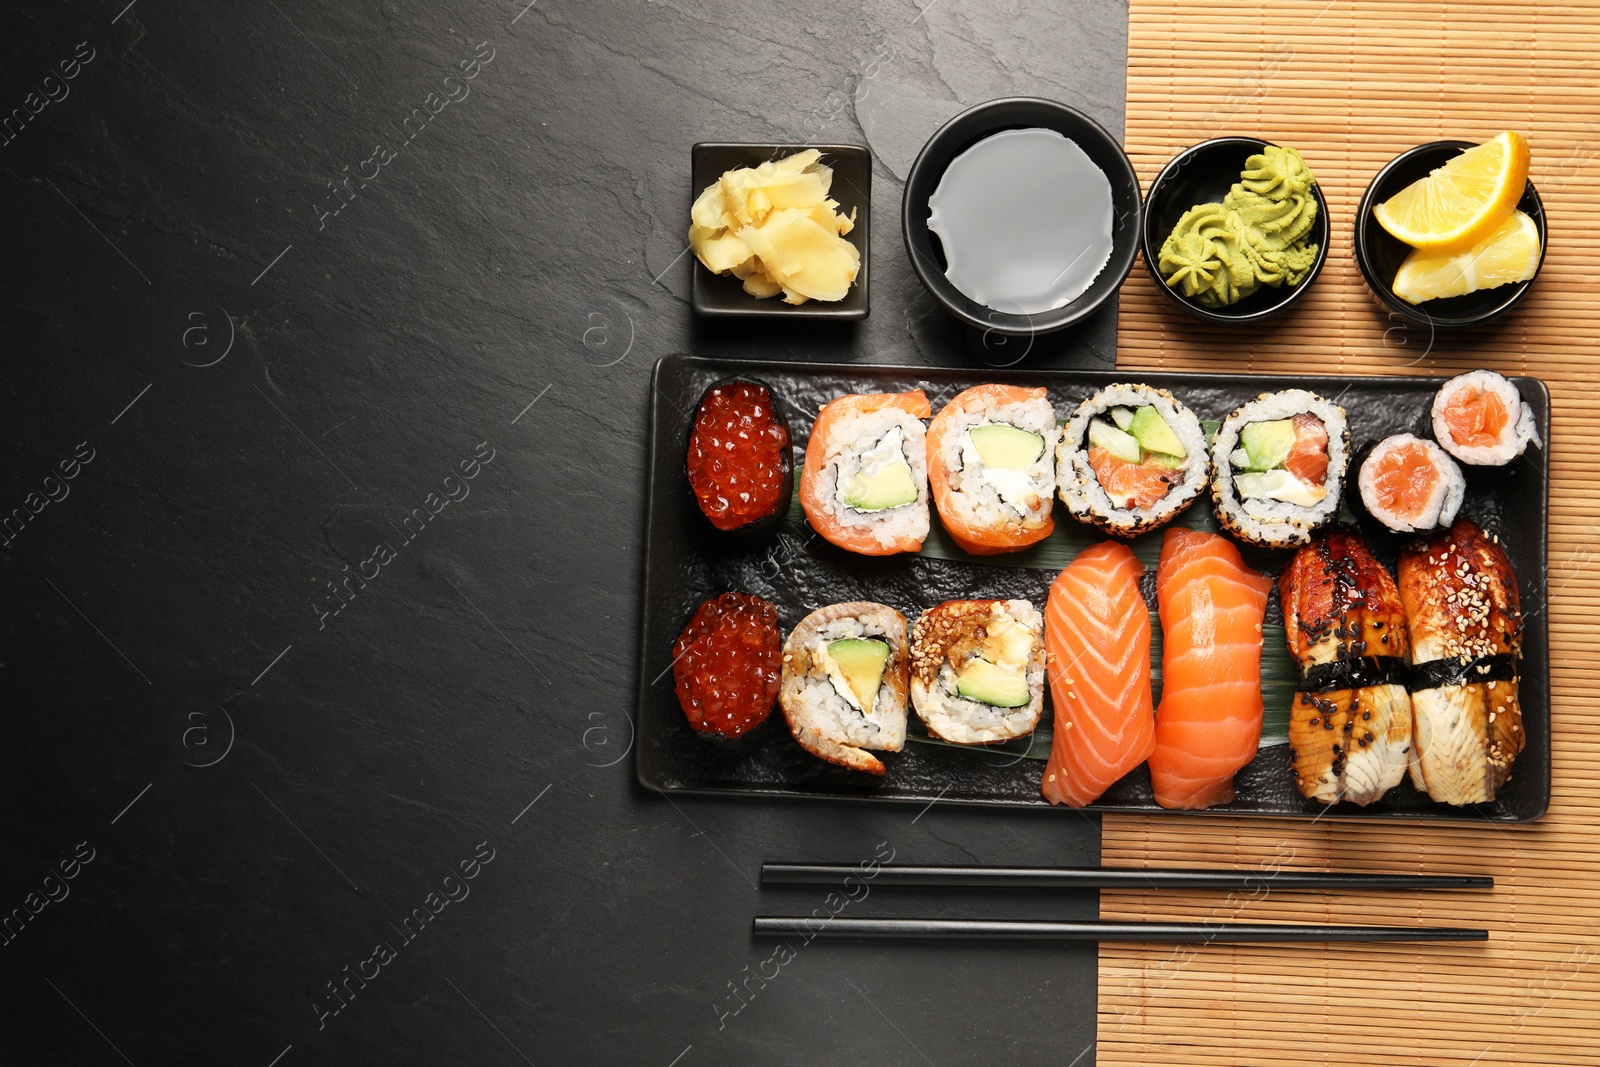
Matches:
[634,355,1550,822]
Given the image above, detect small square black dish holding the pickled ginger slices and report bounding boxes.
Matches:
[683,141,872,322]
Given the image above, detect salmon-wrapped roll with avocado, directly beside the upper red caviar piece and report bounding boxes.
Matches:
[800,389,933,555]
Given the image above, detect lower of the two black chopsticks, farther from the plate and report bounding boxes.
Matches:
[755,915,1490,944]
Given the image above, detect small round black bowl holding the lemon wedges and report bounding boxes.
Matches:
[1355,141,1549,330]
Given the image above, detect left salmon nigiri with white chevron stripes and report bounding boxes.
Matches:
[1042,541,1155,808]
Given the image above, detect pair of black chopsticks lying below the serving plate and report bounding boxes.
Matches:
[754,864,1494,944]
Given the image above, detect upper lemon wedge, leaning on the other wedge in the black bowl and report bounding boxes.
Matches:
[1373,130,1528,250]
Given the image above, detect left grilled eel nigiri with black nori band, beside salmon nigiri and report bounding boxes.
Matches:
[1278,530,1411,805]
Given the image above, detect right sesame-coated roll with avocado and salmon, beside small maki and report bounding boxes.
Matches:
[1211,389,1350,549]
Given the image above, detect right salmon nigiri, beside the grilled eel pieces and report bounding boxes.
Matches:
[1150,528,1272,808]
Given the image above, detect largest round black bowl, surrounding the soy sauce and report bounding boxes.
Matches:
[901,96,1141,338]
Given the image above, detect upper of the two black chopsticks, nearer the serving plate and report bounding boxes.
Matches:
[762,864,1494,893]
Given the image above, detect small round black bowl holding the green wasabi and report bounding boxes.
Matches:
[1142,138,1330,325]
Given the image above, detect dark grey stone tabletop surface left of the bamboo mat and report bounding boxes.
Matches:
[0,0,1125,1067]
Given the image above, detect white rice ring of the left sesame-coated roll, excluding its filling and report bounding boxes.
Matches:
[1056,384,1210,537]
